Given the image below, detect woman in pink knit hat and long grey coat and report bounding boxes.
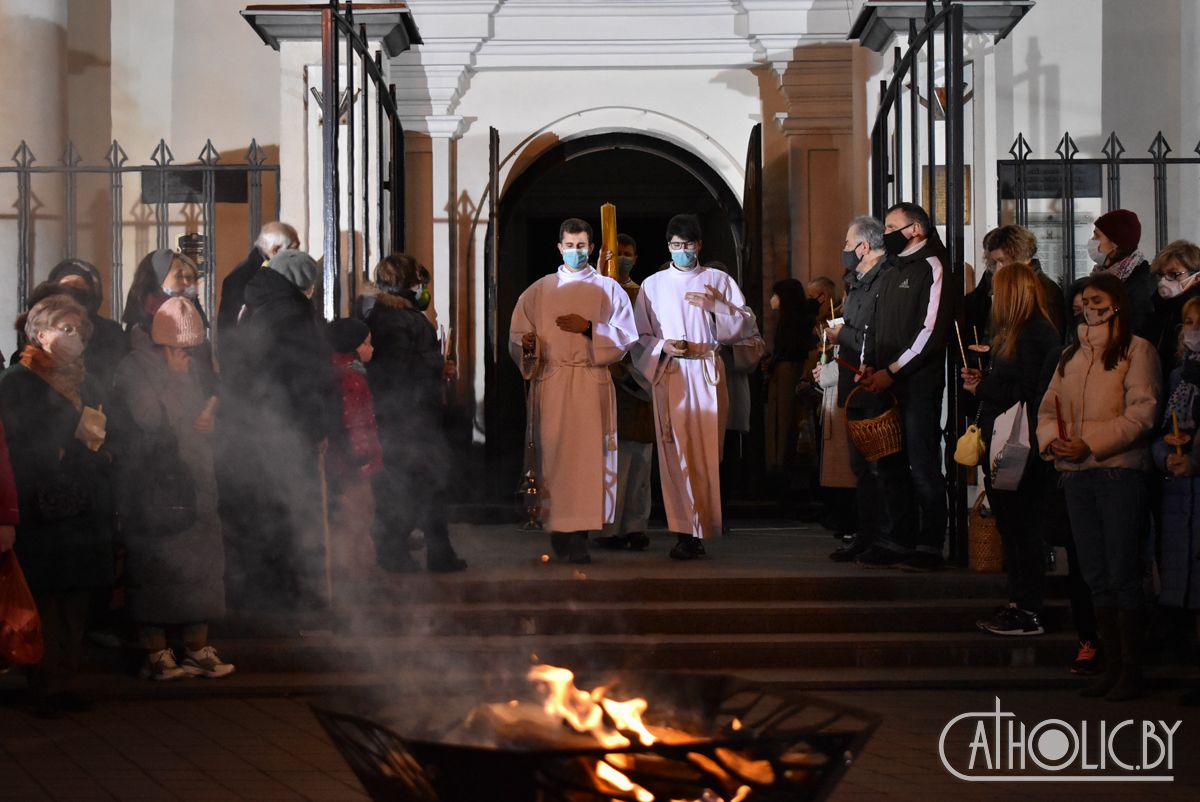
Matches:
[113,298,233,680]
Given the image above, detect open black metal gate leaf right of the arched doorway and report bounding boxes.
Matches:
[871,0,968,563]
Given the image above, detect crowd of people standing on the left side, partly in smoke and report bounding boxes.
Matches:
[0,222,467,717]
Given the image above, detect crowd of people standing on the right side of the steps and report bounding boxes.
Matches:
[801,203,1200,704]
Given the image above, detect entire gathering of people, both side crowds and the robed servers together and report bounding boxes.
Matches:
[0,203,1200,716]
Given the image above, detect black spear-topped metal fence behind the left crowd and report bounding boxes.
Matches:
[0,139,280,319]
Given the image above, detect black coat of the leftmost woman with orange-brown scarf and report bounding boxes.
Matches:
[0,364,114,594]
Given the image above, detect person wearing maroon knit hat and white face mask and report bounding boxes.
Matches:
[1087,209,1158,342]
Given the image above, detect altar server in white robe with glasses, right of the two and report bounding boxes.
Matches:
[634,215,758,559]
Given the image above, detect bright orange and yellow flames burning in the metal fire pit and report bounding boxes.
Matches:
[528,665,748,802]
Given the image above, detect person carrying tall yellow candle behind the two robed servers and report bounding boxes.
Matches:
[596,234,654,551]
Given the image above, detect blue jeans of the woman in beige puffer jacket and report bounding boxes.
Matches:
[1062,468,1150,610]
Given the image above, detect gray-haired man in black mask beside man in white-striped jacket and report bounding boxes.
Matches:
[827,215,899,562]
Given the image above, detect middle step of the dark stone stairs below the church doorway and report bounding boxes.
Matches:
[212,598,1070,639]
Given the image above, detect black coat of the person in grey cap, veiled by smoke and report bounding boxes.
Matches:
[234,270,338,444]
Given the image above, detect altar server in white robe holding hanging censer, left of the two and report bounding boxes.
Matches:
[509,217,637,563]
